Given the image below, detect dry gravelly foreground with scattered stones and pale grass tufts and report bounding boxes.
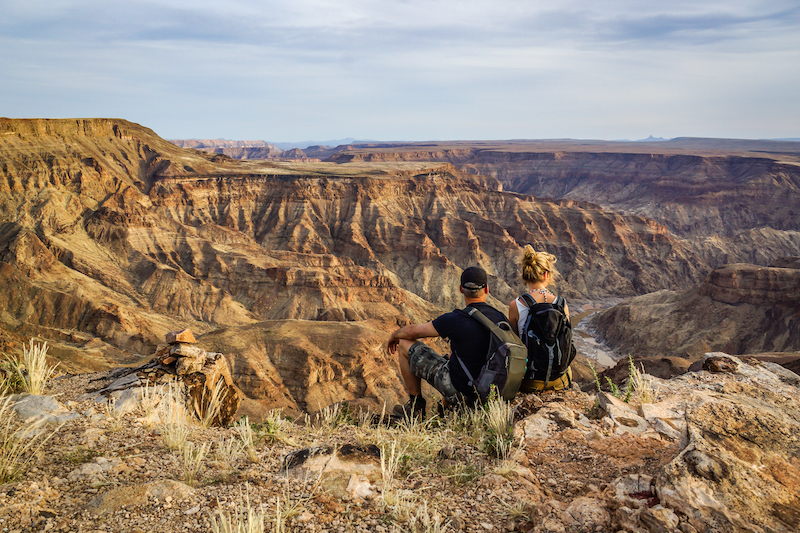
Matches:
[0,373,676,533]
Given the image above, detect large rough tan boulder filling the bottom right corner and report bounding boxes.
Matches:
[651,354,800,533]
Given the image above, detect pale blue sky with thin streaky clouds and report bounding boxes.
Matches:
[0,0,800,142]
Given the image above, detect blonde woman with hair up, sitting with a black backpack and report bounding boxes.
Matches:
[508,244,575,392]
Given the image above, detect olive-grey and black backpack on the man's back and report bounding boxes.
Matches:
[455,307,528,402]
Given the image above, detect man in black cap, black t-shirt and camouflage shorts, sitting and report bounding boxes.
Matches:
[386,267,508,418]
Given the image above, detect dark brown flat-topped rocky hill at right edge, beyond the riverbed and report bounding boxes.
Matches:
[594,257,800,360]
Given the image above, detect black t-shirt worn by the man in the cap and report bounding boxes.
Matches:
[433,302,508,396]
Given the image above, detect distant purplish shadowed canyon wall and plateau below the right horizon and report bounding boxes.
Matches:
[324,139,800,266]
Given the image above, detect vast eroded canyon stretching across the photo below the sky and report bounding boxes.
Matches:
[0,119,800,413]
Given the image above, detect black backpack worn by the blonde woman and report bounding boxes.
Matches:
[520,294,576,386]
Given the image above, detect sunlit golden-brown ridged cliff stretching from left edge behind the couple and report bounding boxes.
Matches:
[0,119,736,409]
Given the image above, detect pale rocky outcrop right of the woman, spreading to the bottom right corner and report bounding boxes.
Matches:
[516,353,800,533]
